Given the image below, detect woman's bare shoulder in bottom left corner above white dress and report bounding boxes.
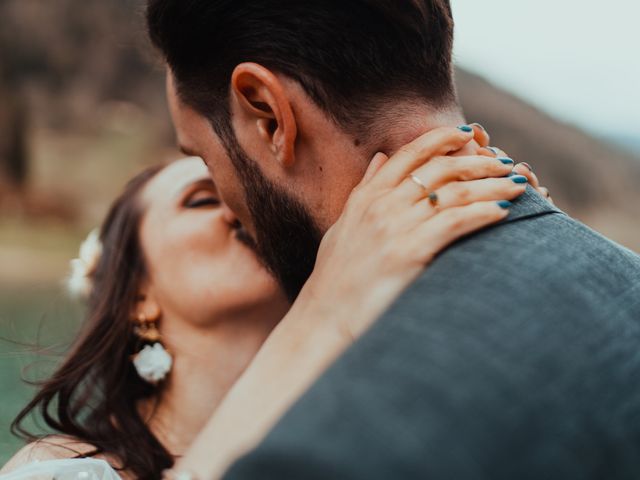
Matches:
[0,435,94,473]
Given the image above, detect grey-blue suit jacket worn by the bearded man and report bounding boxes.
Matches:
[224,188,640,480]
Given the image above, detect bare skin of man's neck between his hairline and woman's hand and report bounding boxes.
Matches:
[298,101,470,232]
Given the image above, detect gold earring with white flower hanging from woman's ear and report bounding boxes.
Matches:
[133,313,173,385]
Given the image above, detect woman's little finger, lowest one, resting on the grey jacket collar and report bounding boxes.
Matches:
[409,201,510,265]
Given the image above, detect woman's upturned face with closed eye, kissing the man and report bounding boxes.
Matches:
[140,158,287,326]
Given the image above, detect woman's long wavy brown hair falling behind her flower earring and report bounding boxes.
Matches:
[11,165,173,479]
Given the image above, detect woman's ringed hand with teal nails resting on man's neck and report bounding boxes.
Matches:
[299,127,537,338]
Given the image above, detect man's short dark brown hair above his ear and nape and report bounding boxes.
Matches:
[147,0,456,138]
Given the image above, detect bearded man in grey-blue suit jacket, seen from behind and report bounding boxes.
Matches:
[147,0,640,479]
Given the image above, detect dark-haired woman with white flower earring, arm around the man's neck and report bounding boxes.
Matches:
[0,126,552,479]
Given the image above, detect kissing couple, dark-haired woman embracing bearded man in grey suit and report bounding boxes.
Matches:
[0,0,640,480]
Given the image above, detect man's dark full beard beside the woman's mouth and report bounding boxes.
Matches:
[225,129,322,302]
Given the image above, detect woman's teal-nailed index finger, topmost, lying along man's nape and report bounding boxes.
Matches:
[369,125,474,189]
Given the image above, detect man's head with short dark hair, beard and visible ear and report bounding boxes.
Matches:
[147,0,459,297]
